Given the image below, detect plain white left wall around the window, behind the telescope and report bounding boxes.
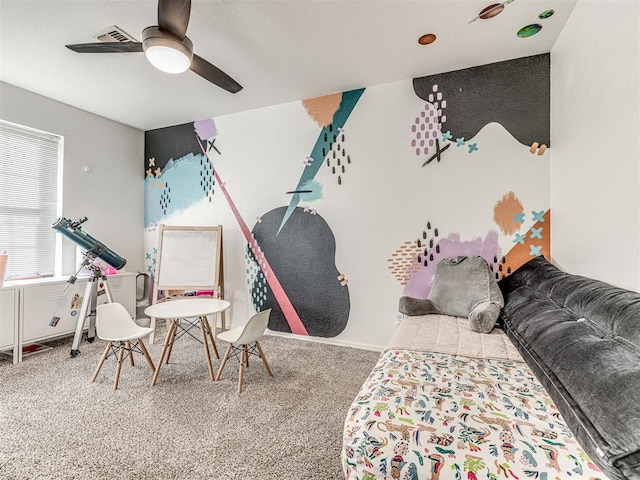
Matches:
[0,82,144,275]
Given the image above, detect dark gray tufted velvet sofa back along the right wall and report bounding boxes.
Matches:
[499,257,640,480]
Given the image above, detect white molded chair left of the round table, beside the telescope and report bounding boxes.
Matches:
[91,303,155,390]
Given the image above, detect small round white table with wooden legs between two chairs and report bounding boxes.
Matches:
[144,297,231,387]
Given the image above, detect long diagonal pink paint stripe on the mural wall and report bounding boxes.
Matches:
[198,138,309,335]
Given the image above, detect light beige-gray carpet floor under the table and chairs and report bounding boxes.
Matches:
[0,326,379,480]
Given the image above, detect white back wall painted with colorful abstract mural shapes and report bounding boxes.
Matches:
[145,55,550,347]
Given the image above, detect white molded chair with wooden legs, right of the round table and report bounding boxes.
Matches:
[216,309,273,395]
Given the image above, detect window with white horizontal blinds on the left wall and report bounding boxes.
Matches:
[0,120,63,276]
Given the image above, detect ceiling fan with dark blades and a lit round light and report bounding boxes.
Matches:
[65,0,242,93]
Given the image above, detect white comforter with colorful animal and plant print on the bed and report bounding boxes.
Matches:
[342,350,606,480]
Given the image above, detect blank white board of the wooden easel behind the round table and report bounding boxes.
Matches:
[155,225,222,290]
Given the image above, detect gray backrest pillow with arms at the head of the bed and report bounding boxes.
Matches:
[399,256,504,333]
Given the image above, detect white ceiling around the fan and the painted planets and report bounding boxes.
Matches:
[0,0,577,130]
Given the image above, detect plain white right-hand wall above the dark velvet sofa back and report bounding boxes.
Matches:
[551,0,640,291]
